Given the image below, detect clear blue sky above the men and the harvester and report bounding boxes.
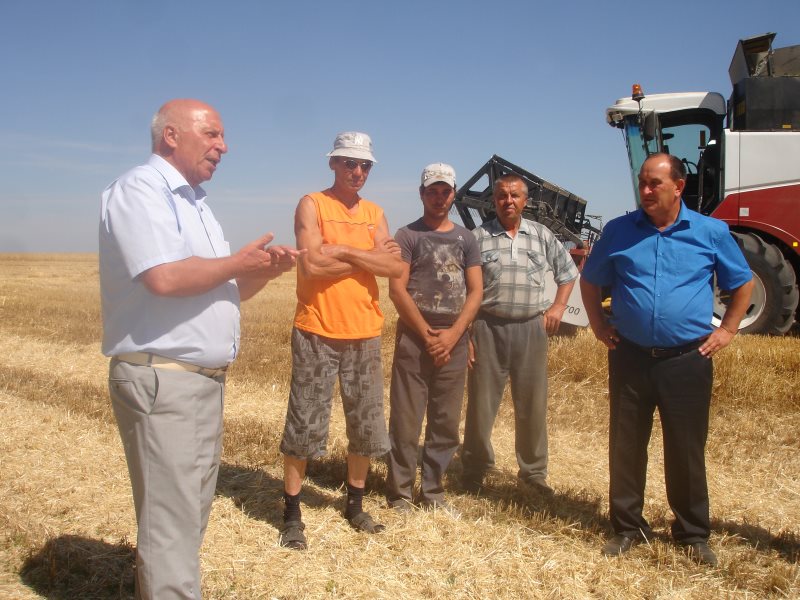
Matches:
[0,0,800,252]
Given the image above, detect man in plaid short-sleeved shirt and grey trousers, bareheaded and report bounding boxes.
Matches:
[461,173,578,495]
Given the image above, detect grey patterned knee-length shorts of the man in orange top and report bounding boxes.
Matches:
[281,328,389,459]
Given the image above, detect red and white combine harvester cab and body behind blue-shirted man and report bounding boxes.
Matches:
[606,33,800,335]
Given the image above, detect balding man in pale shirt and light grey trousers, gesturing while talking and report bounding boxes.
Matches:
[100,100,298,600]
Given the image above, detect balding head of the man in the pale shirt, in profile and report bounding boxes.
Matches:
[150,98,228,187]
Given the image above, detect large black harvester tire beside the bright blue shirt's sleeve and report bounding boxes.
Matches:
[731,232,798,335]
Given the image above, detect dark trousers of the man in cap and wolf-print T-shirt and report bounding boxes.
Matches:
[386,321,467,503]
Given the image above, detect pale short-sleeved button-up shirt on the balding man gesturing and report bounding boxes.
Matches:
[100,154,240,368]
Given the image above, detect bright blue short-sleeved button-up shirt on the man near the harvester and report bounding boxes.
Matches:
[581,202,752,347]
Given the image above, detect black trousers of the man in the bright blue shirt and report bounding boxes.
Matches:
[608,341,714,544]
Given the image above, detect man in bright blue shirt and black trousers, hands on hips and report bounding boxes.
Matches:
[581,154,753,566]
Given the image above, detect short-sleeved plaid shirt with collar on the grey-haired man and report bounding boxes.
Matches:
[473,219,578,319]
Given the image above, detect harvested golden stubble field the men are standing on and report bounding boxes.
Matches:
[0,255,800,599]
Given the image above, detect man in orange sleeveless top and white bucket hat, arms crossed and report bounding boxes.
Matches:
[280,131,403,550]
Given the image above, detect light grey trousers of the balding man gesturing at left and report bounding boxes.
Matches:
[108,359,225,600]
